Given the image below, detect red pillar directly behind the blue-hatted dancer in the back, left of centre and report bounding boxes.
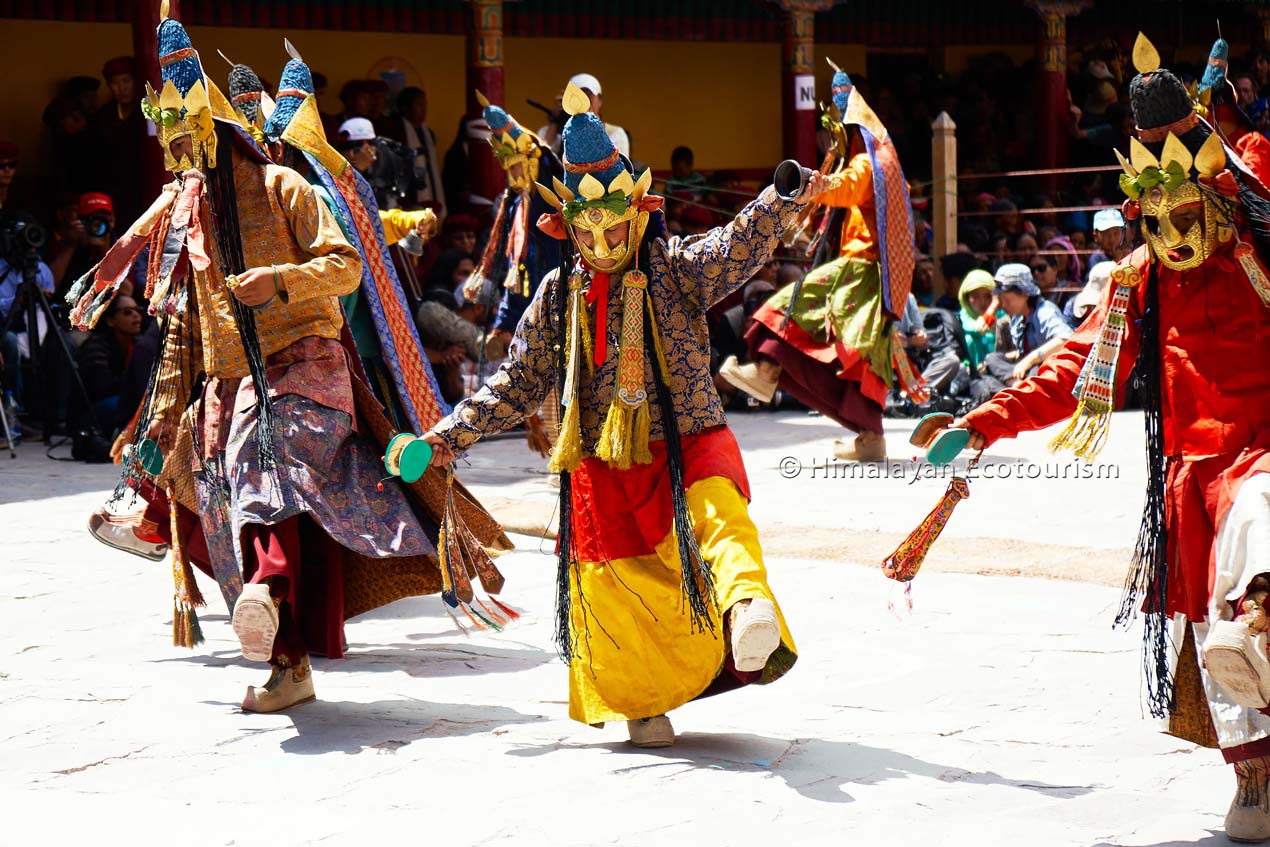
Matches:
[467,0,507,211]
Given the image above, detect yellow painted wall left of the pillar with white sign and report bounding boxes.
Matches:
[0,20,787,184]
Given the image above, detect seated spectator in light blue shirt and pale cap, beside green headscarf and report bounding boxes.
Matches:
[975,264,1072,403]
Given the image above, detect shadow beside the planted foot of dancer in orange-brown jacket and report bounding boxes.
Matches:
[279,700,547,756]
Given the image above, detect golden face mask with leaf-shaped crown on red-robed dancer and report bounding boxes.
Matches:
[1116,133,1234,270]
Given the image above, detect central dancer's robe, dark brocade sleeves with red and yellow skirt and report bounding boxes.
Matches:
[434,188,796,724]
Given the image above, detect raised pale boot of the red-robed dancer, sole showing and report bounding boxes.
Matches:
[1204,589,1270,709]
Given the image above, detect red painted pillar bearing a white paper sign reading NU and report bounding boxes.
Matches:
[780,0,833,168]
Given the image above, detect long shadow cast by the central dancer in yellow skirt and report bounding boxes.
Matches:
[508,733,1097,803]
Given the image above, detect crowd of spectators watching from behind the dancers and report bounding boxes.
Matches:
[7,39,1270,457]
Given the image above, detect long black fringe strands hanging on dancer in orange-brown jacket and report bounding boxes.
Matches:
[207,123,278,471]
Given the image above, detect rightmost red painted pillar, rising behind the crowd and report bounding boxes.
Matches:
[1027,0,1088,194]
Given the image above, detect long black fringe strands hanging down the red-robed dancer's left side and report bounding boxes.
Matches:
[1115,263,1173,717]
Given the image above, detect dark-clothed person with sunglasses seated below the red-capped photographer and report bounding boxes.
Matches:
[71,295,159,437]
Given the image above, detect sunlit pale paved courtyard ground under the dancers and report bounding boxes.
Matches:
[0,414,1233,847]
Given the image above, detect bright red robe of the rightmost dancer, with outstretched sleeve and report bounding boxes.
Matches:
[965,236,1270,621]
